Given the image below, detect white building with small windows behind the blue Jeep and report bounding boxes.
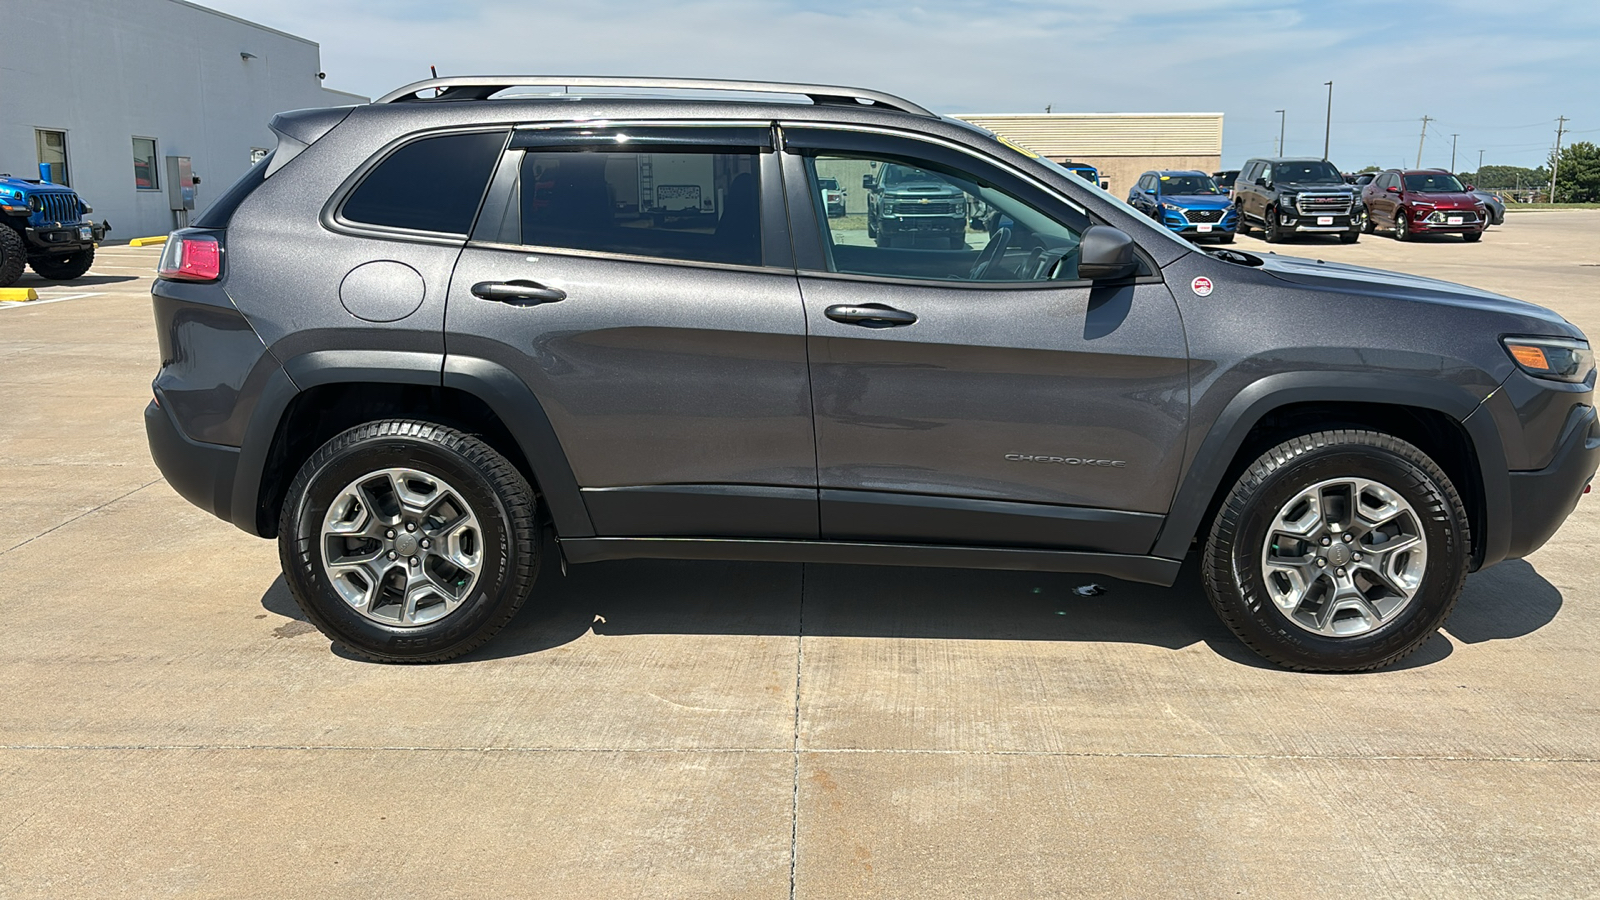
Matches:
[0,0,366,242]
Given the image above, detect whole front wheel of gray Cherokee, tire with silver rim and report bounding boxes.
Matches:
[1202,429,1472,671]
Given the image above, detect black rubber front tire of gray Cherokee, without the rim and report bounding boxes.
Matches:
[1202,429,1472,671]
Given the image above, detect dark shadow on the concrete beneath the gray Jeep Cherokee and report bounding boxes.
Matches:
[261,544,1562,671]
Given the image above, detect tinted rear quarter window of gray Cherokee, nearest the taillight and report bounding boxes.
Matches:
[342,131,506,234]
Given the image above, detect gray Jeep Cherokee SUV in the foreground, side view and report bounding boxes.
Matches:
[144,77,1600,671]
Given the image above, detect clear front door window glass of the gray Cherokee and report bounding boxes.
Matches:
[805,152,1082,282]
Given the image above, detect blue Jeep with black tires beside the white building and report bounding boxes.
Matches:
[0,175,110,288]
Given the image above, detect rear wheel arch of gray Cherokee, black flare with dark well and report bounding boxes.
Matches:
[232,349,594,538]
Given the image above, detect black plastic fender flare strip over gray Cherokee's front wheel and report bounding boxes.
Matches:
[1150,372,1510,565]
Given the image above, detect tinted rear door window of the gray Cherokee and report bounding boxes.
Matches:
[522,151,762,266]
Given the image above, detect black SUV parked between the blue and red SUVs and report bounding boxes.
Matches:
[1234,159,1362,243]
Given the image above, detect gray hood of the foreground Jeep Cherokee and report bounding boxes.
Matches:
[1261,253,1584,340]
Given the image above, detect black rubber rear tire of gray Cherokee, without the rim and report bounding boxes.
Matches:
[278,420,541,663]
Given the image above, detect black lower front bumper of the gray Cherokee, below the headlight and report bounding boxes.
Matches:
[1506,405,1600,559]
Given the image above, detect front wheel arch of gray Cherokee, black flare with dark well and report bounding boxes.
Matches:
[1150,372,1510,569]
